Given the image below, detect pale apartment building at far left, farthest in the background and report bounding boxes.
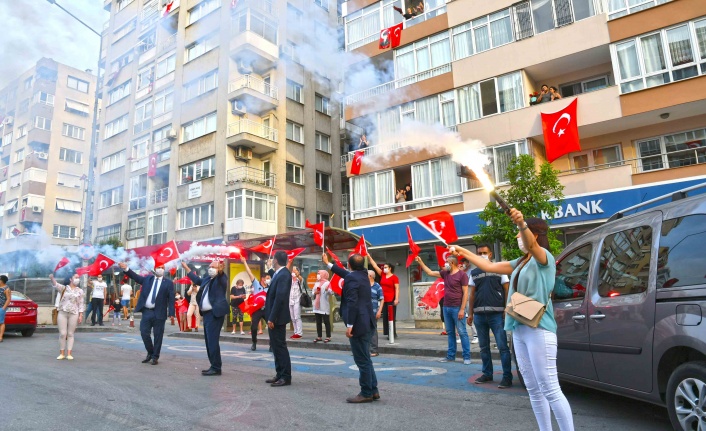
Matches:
[0,58,96,249]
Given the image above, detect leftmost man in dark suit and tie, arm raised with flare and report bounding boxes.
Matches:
[119,262,174,365]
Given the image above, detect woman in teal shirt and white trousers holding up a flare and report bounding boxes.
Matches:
[456,208,574,431]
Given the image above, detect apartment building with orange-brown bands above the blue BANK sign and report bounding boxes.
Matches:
[341,0,706,318]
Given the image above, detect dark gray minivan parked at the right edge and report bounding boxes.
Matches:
[553,184,706,431]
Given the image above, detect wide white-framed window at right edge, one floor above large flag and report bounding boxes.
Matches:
[611,20,706,93]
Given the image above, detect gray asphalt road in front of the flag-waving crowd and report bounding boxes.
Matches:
[0,333,671,431]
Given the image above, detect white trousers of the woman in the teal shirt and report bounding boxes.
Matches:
[512,325,574,431]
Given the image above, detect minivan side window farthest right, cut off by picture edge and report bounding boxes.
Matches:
[657,214,706,289]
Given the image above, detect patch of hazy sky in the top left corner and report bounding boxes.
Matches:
[0,0,110,88]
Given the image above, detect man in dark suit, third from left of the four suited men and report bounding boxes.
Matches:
[265,250,292,387]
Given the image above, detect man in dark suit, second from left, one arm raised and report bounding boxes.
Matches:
[181,260,230,376]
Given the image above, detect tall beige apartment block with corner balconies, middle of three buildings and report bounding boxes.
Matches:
[92,0,341,249]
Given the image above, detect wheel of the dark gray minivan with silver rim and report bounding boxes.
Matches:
[667,361,706,431]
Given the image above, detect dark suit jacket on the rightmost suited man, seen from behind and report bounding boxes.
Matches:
[331,264,375,337]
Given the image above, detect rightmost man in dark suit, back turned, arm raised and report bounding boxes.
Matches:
[322,253,380,403]
